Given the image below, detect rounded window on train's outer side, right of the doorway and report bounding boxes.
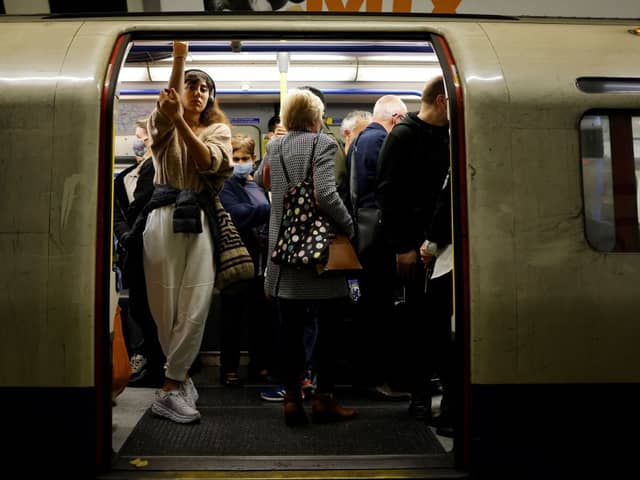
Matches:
[580,110,640,252]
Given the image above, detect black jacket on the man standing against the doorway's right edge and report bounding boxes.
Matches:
[376,113,449,253]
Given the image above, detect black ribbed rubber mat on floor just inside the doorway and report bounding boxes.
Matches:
[119,387,444,456]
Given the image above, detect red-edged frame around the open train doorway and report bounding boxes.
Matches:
[95,28,471,472]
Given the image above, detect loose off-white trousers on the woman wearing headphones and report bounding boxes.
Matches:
[143,205,215,382]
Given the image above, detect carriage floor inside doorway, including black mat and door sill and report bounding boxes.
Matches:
[112,366,454,478]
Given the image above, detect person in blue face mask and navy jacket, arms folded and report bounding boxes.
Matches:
[220,135,274,386]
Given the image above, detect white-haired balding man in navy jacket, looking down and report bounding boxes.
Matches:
[346,95,407,397]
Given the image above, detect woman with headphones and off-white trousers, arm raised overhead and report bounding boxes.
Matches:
[143,41,233,423]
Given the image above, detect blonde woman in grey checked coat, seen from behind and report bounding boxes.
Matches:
[265,90,355,425]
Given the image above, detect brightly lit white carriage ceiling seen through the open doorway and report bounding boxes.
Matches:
[119,40,441,102]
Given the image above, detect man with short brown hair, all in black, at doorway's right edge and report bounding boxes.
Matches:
[376,76,449,426]
